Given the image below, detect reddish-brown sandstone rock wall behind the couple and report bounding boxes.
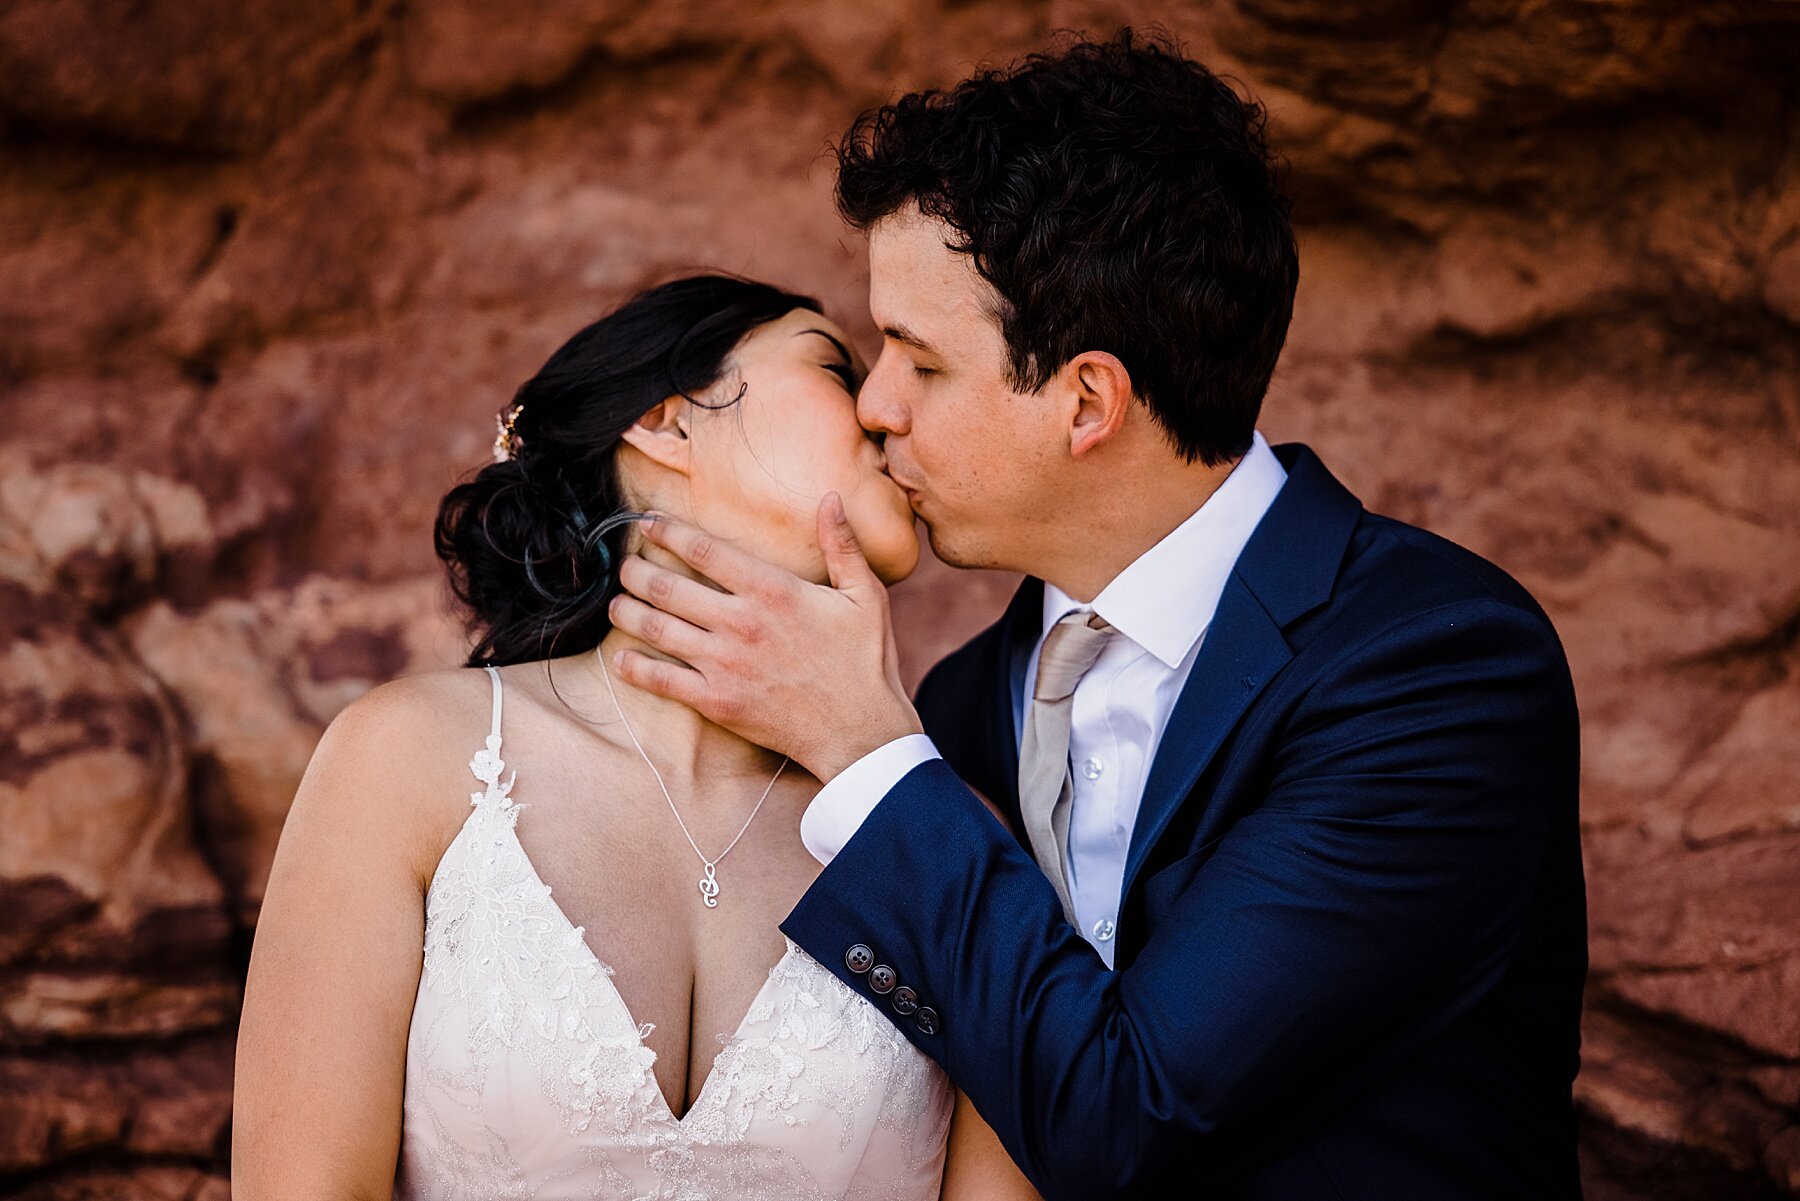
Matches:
[0,0,1800,1201]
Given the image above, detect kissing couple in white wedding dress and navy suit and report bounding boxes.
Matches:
[232,31,1586,1201]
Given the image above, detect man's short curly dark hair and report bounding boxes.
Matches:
[837,29,1300,465]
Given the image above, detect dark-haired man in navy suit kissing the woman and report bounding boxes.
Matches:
[614,34,1586,1201]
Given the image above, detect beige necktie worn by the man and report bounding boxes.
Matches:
[1019,612,1112,922]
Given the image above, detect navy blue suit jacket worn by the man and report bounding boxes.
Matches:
[783,445,1588,1201]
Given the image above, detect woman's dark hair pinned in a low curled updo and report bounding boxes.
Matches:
[434,275,821,666]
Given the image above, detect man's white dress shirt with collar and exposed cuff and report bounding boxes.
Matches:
[799,432,1287,967]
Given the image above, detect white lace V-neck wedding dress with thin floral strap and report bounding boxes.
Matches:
[394,668,952,1201]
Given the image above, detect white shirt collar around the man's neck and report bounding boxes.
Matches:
[1039,430,1287,670]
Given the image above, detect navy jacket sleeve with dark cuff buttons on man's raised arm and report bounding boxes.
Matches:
[783,600,1575,1201]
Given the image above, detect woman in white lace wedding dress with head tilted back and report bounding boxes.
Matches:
[232,275,1035,1201]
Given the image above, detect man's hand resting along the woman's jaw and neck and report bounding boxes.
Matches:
[610,493,922,780]
